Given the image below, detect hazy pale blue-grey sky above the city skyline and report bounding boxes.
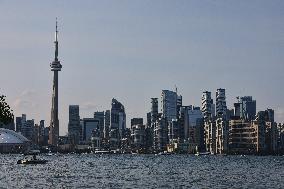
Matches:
[0,0,284,135]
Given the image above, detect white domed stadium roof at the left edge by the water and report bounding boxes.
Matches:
[0,128,30,153]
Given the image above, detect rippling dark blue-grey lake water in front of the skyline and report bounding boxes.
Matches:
[0,154,284,188]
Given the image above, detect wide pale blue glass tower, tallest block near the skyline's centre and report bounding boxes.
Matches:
[161,90,177,122]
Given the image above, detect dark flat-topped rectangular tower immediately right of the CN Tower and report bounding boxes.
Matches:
[68,105,81,144]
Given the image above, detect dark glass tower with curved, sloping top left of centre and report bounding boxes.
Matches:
[110,98,126,138]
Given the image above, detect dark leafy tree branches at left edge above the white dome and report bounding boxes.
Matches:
[0,95,14,125]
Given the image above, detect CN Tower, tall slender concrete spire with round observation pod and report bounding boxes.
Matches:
[48,19,62,146]
